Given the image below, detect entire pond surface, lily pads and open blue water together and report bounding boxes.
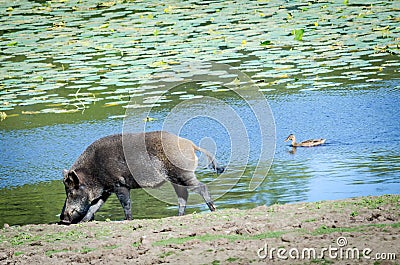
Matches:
[0,1,400,227]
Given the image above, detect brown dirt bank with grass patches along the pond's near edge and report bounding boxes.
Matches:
[0,195,400,264]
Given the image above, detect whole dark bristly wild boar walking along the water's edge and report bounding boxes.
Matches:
[60,131,224,224]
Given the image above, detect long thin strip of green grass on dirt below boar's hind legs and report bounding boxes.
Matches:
[153,231,290,246]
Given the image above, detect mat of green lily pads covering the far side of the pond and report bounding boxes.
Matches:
[0,0,400,120]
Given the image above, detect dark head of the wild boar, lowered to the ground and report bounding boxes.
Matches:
[60,170,99,224]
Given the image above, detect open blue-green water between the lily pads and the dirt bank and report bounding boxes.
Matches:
[0,82,400,225]
